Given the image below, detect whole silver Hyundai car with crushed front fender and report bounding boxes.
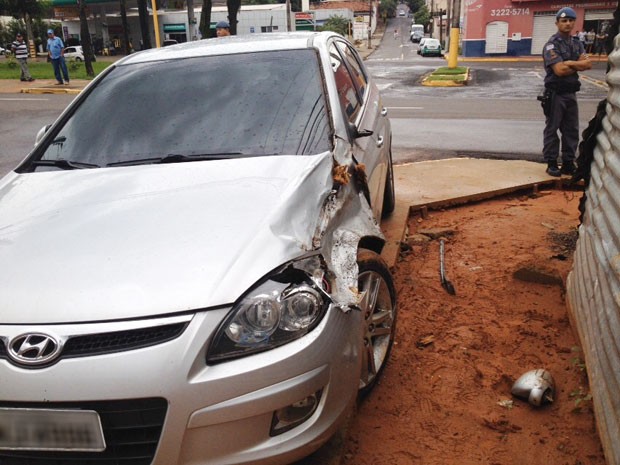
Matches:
[0,32,396,465]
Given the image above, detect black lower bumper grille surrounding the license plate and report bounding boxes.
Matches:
[0,398,168,465]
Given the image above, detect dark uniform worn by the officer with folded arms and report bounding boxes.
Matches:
[543,29,585,170]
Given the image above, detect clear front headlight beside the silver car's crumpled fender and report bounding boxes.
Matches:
[207,255,331,363]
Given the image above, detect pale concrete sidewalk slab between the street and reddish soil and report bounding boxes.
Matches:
[381,158,562,267]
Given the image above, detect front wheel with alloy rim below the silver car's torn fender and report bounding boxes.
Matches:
[357,249,396,399]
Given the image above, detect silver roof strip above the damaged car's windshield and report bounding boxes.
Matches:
[117,31,342,65]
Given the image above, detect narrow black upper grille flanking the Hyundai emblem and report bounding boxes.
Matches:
[0,322,188,360]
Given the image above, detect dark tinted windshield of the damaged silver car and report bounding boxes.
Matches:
[30,50,331,169]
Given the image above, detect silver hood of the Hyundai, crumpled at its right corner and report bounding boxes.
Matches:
[0,153,333,324]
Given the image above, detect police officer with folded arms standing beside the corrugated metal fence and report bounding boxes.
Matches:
[543,8,592,176]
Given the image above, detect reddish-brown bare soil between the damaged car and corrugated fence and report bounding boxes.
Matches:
[343,190,605,465]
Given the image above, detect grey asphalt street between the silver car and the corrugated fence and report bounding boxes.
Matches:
[366,18,607,163]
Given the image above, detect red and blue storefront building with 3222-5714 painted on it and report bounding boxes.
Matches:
[461,0,618,57]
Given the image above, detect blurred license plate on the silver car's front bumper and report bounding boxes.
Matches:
[0,408,105,452]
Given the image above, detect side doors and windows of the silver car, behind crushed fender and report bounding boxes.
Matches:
[330,40,389,218]
